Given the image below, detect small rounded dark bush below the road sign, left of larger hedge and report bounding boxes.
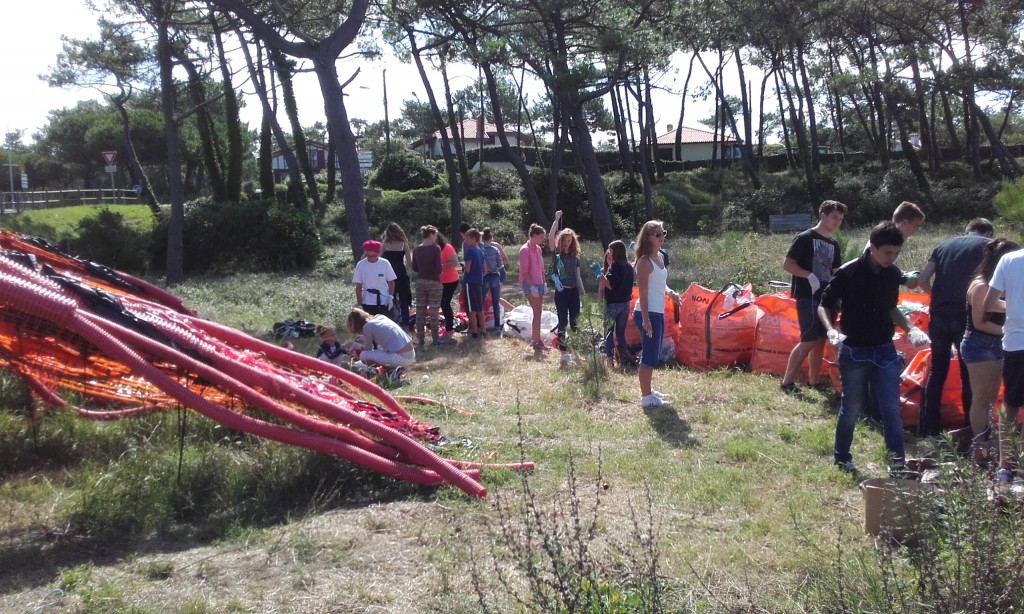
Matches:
[75,209,152,274]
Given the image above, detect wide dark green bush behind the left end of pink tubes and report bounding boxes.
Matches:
[154,199,323,273]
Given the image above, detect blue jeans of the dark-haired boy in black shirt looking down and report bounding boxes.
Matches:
[834,342,904,469]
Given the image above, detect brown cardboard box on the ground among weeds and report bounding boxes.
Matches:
[860,478,935,542]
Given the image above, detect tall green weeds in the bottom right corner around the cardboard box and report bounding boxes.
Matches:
[800,459,1024,614]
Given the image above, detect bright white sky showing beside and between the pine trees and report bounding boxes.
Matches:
[0,0,711,146]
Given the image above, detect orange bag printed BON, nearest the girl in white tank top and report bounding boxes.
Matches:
[676,283,758,369]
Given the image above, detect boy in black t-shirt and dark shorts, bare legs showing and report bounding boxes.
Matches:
[780,201,847,392]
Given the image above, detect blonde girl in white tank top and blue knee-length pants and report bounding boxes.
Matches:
[633,220,669,407]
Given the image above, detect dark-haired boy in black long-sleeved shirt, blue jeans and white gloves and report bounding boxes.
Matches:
[818,222,929,473]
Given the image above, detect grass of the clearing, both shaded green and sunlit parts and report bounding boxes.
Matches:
[0,221,1019,612]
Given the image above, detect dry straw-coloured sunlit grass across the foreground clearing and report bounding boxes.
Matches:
[0,223,991,613]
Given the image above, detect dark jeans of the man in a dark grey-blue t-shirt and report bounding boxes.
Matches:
[918,311,971,437]
